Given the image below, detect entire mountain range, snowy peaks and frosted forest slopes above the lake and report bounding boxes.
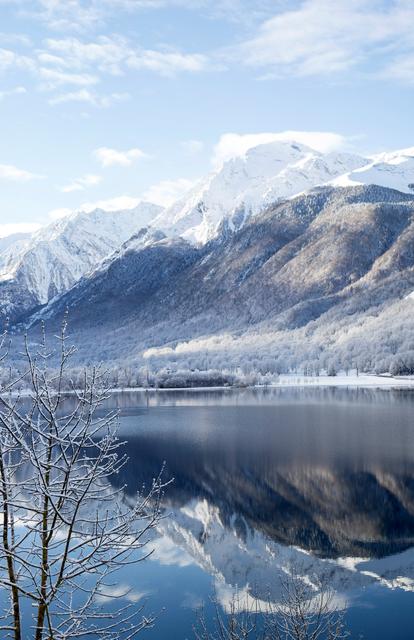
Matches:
[0,142,414,372]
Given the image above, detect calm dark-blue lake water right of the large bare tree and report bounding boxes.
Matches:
[88,388,414,640]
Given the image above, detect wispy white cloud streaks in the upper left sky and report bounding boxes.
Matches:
[0,30,211,107]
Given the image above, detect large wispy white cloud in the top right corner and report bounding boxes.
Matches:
[233,0,414,76]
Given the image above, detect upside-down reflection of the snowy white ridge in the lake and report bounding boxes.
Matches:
[154,500,414,604]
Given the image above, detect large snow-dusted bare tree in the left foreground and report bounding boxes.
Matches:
[0,323,165,640]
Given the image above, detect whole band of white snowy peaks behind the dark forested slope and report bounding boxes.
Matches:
[0,141,414,330]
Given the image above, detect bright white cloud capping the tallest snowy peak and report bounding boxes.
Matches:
[212,131,348,168]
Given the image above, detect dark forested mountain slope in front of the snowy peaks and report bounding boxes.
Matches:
[27,186,414,368]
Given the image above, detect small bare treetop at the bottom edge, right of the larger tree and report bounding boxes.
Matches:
[194,566,349,640]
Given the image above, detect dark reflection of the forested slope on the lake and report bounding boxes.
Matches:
[105,389,414,558]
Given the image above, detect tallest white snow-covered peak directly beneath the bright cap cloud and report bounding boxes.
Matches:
[154,142,368,243]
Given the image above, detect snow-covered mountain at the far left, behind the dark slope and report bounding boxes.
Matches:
[0,202,161,321]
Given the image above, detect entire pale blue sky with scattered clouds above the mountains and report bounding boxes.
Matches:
[0,0,414,236]
